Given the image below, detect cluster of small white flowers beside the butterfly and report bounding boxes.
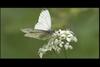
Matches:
[38,29,77,58]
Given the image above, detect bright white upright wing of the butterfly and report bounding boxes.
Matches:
[34,9,51,31]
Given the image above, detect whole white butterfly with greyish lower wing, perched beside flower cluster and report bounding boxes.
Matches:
[21,9,53,40]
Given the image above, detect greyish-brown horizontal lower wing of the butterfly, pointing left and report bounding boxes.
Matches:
[21,28,51,40]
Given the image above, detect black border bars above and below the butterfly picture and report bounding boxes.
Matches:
[0,0,100,66]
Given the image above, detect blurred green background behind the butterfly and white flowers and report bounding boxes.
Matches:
[1,8,99,59]
